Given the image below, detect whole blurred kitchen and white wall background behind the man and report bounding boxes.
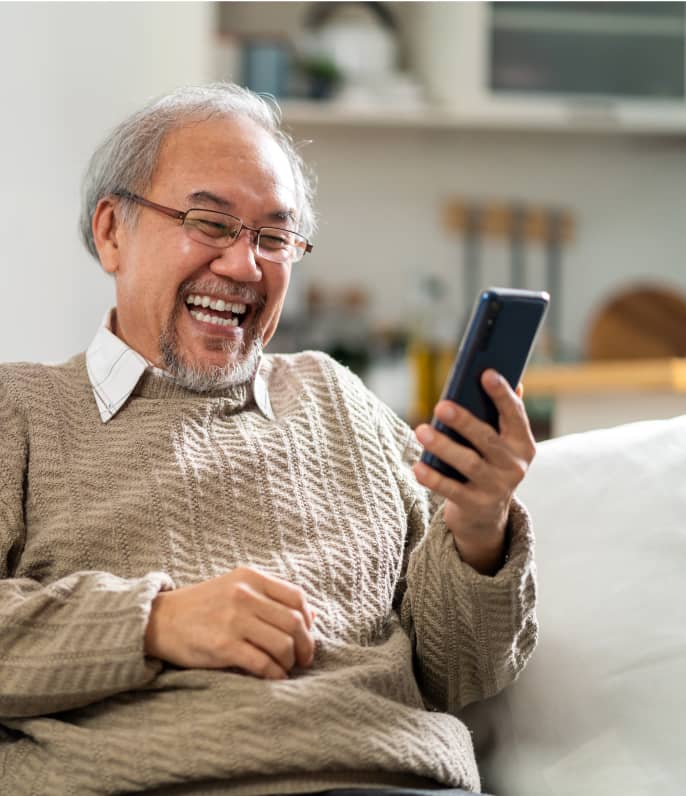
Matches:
[0,2,686,438]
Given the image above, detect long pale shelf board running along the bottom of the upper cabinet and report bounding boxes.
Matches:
[280,97,686,137]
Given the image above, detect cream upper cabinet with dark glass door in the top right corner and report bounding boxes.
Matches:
[414,2,686,133]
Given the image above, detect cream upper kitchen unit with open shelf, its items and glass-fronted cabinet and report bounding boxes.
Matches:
[218,2,686,136]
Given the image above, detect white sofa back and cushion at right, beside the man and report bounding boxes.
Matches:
[465,415,686,796]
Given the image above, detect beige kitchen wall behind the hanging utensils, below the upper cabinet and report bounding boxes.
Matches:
[295,127,686,352]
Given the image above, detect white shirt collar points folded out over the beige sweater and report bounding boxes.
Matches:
[86,309,274,423]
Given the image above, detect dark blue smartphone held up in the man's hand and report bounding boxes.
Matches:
[422,288,550,483]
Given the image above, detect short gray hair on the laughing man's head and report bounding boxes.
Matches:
[79,83,316,259]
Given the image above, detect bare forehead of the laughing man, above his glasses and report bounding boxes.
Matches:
[152,117,295,206]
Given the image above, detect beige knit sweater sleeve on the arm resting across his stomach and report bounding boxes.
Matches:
[0,376,174,719]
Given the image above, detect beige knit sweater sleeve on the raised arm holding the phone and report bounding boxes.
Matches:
[379,398,538,714]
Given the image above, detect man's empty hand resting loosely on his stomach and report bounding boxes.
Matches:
[145,567,314,680]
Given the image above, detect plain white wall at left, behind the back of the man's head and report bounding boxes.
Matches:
[0,2,214,361]
